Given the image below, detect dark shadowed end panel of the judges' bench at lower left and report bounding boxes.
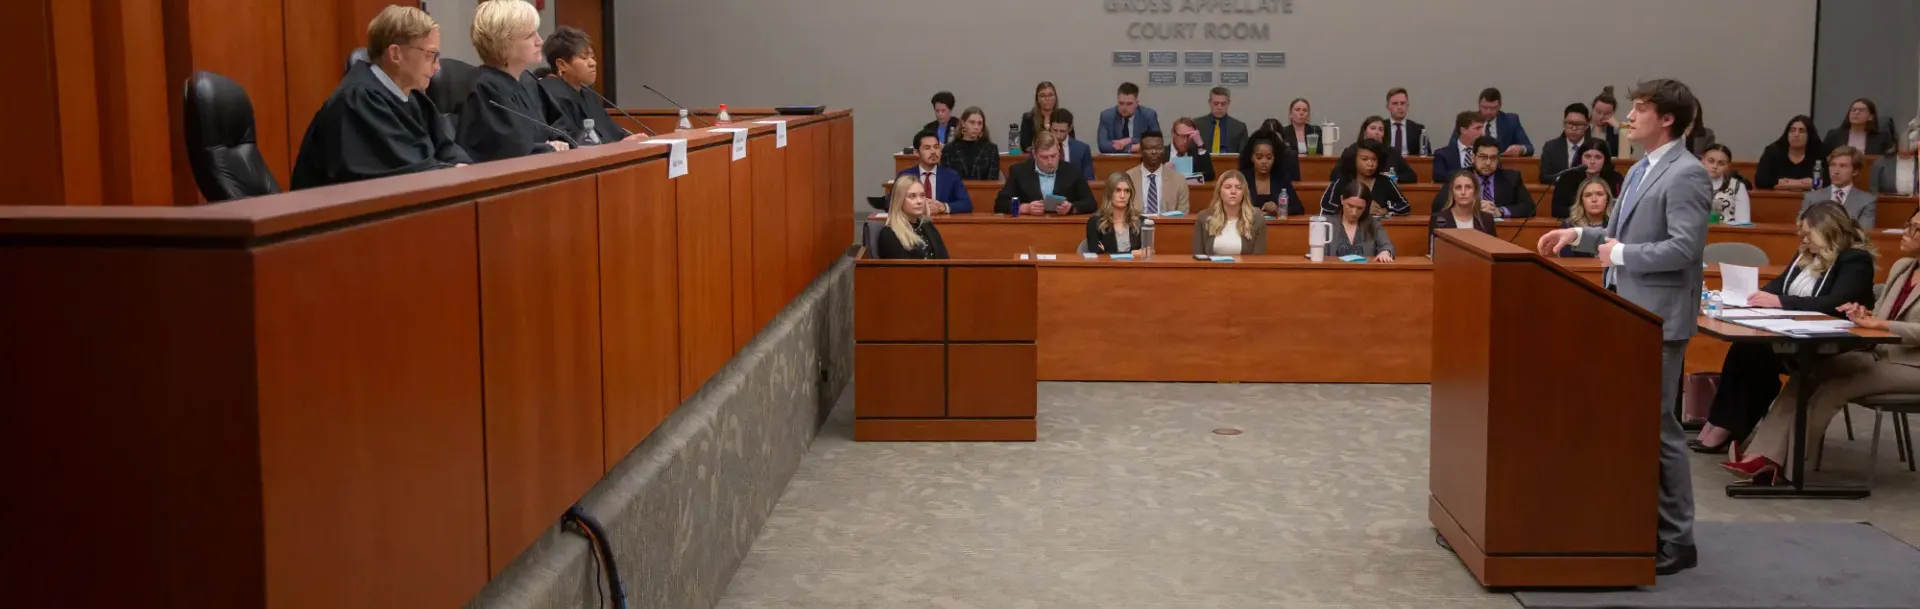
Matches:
[0,248,267,609]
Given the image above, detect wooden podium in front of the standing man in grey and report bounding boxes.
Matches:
[1427,231,1663,588]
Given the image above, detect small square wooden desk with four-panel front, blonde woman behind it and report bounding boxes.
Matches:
[852,252,1039,442]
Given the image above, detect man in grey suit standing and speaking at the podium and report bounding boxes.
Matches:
[1540,79,1713,574]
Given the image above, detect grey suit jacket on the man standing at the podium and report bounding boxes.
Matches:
[1574,144,1713,340]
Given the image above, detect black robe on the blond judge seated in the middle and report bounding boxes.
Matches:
[455,65,563,161]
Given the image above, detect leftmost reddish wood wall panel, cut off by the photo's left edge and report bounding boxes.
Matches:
[0,0,65,206]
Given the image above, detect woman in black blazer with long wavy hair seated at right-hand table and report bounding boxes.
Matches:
[1688,204,1874,453]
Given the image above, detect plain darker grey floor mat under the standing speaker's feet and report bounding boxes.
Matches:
[1515,523,1920,609]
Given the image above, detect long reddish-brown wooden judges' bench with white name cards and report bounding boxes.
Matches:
[0,110,854,609]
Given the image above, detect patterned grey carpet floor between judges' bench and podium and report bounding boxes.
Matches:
[718,382,1920,609]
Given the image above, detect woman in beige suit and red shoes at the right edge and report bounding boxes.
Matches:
[1720,206,1920,484]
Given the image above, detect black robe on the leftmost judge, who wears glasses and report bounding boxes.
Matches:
[292,61,472,190]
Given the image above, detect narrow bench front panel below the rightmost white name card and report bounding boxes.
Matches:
[747,136,793,329]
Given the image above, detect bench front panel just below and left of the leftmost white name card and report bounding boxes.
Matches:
[599,159,680,469]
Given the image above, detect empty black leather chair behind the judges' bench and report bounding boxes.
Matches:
[184,71,280,204]
